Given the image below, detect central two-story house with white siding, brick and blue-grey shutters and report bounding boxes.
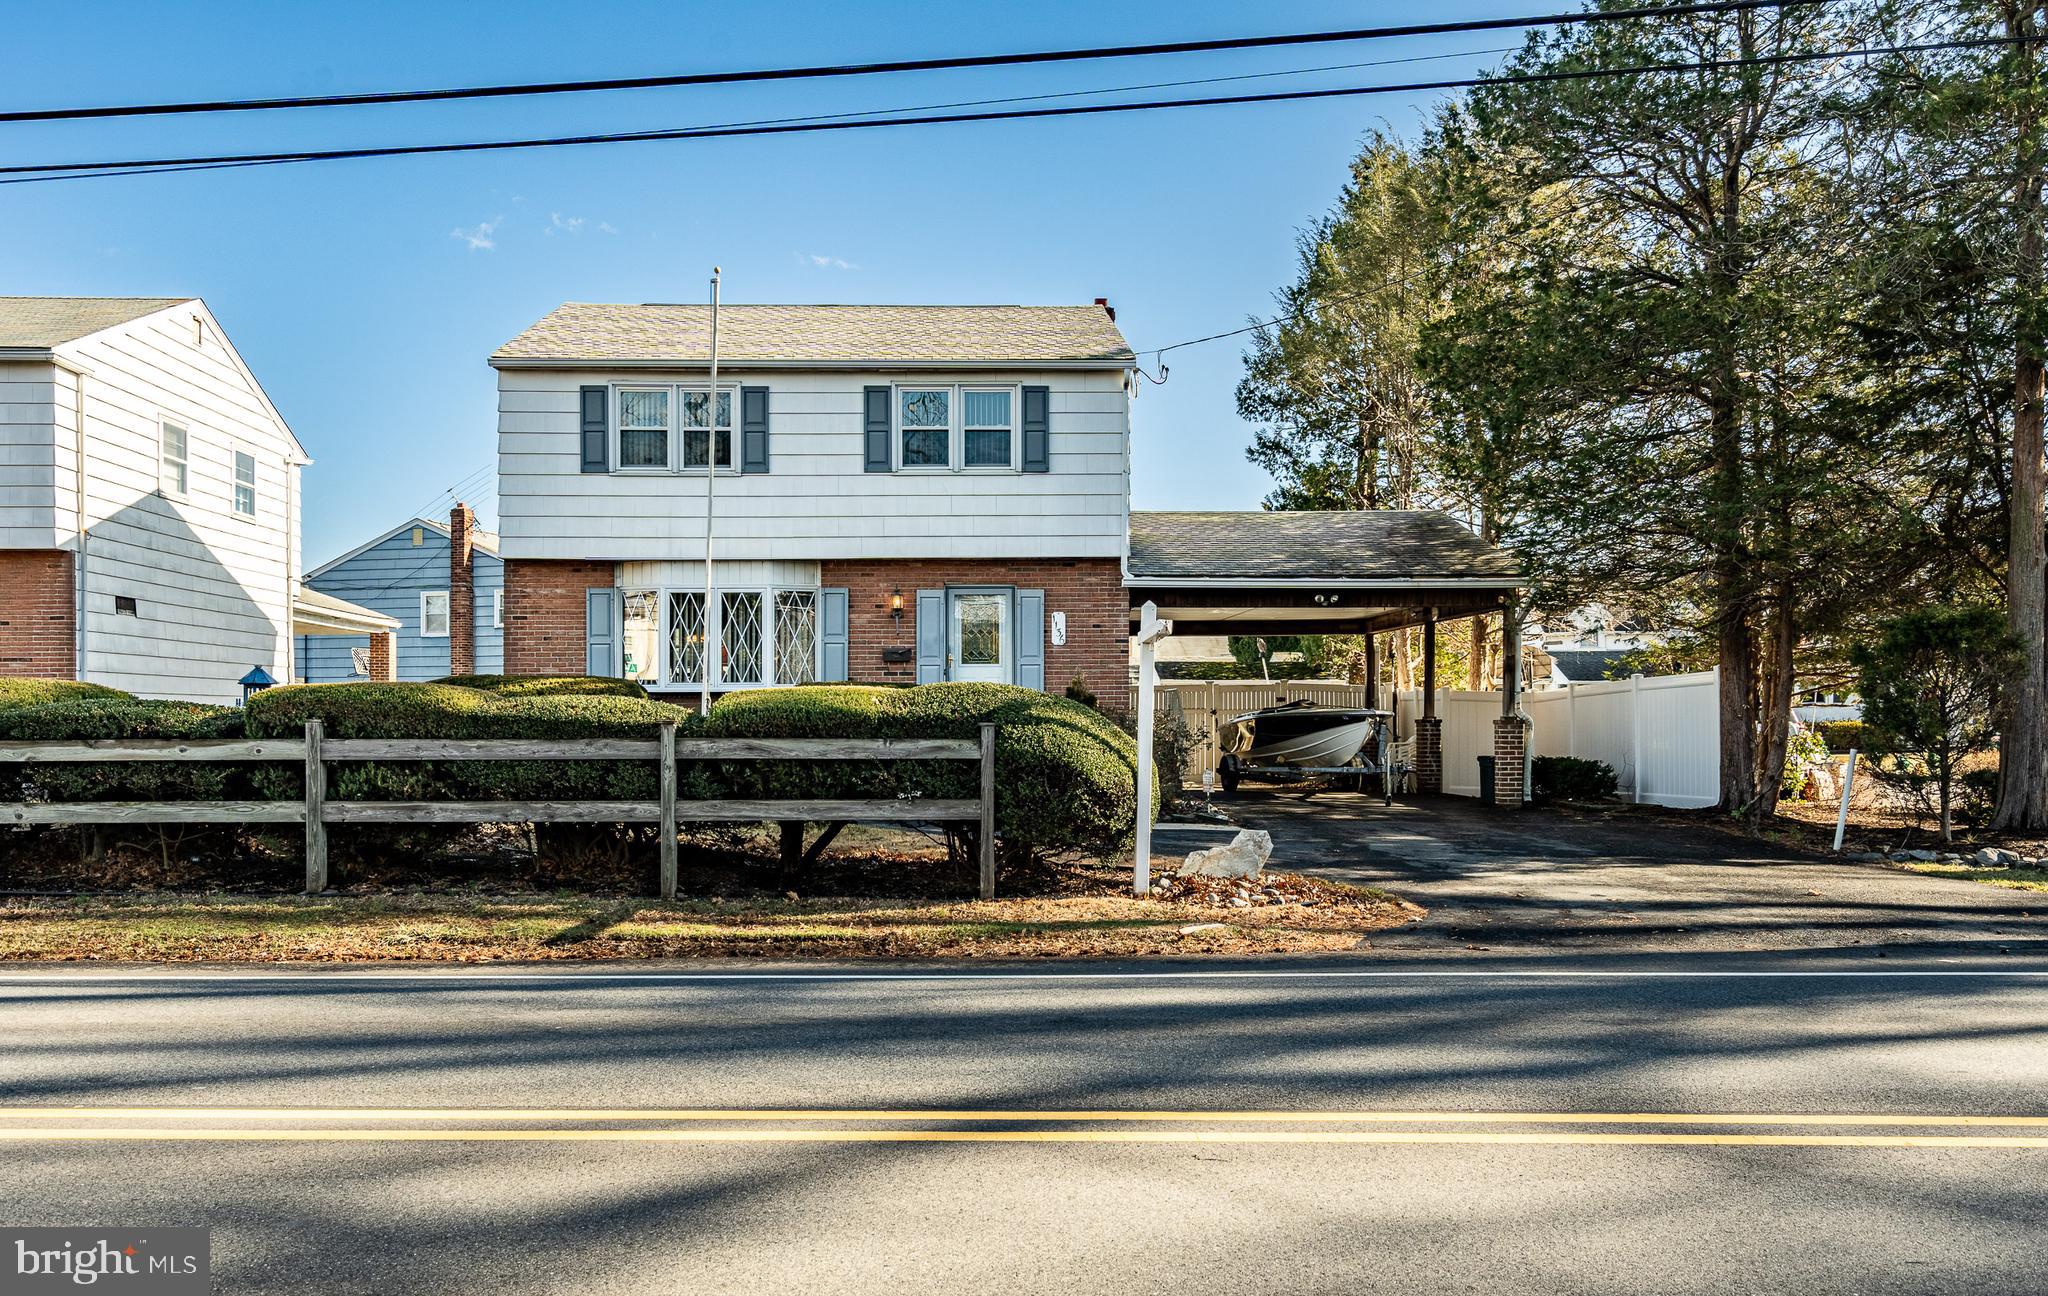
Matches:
[492,301,1135,694]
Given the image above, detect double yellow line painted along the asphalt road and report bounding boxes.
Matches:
[0,1106,2048,1149]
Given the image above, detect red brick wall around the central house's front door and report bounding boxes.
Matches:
[819,559,1130,704]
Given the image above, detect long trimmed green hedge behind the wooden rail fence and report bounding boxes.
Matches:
[0,676,1137,860]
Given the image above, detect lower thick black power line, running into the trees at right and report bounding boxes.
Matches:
[0,37,1998,184]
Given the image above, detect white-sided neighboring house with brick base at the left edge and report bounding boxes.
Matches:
[0,297,391,702]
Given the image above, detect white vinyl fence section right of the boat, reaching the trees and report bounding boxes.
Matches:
[1397,672,1720,809]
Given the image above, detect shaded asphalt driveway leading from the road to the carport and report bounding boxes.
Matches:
[1153,790,2048,956]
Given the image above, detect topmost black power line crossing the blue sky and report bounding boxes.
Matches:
[0,0,1831,123]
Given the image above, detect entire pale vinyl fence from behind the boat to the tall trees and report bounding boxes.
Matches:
[1159,672,1720,809]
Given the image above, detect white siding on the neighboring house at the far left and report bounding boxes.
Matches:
[23,303,299,702]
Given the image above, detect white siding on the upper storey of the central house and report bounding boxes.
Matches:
[498,369,1130,561]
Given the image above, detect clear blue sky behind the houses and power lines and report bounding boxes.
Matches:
[0,0,1544,565]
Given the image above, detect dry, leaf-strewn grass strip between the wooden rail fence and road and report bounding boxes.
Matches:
[0,874,1423,962]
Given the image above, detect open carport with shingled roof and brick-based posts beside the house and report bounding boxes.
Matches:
[1124,510,1528,893]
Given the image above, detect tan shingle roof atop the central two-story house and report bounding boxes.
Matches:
[492,301,1133,364]
